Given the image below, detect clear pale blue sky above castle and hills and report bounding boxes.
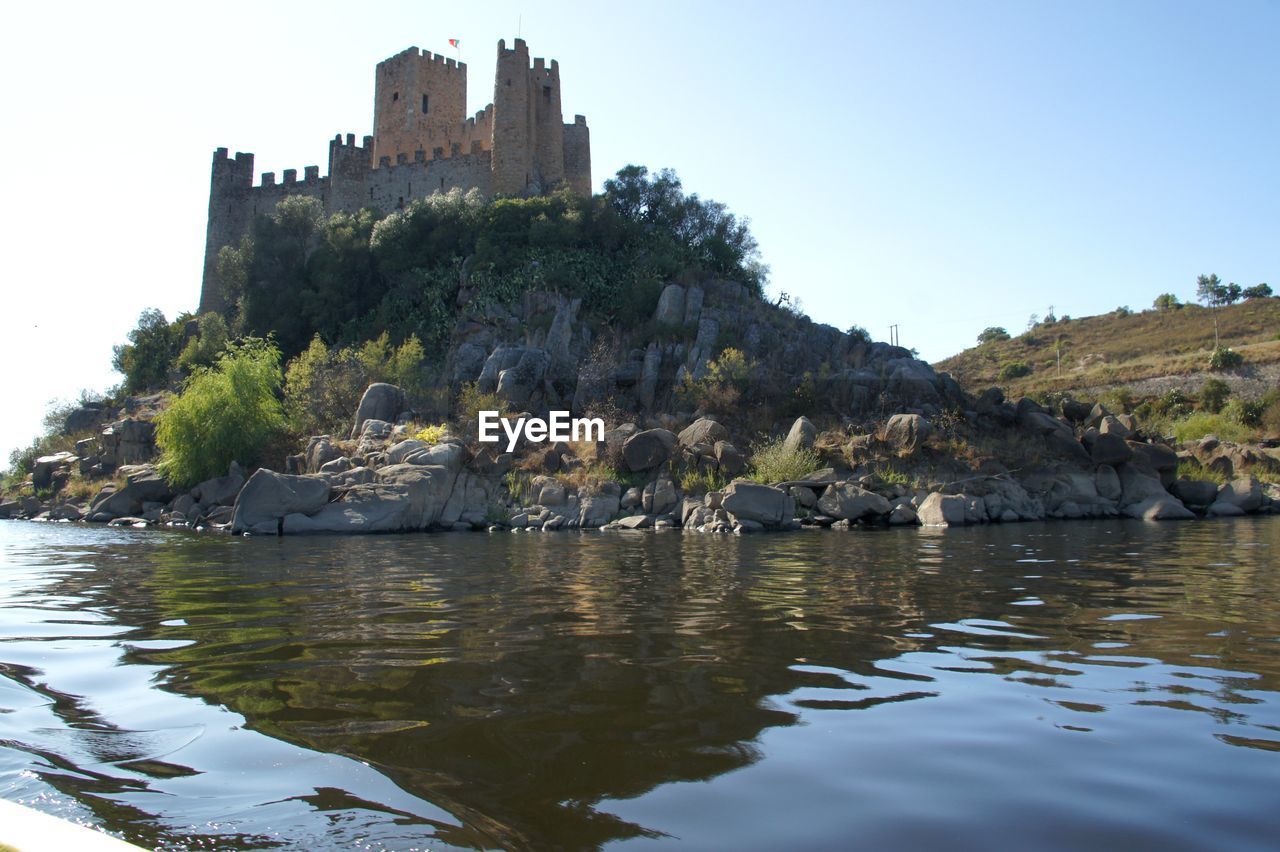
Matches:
[0,0,1280,466]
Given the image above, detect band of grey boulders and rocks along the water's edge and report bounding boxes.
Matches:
[0,384,1280,535]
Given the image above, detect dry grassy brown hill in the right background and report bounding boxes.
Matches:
[934,298,1280,395]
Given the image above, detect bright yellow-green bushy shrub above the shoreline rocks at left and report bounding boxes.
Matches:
[156,338,284,487]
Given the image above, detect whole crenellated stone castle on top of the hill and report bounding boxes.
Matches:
[200,38,591,313]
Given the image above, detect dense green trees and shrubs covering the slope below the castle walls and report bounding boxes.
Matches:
[2,165,768,484]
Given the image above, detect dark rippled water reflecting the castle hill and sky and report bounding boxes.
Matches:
[0,518,1280,849]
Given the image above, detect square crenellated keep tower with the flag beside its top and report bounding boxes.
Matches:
[371,47,467,165]
